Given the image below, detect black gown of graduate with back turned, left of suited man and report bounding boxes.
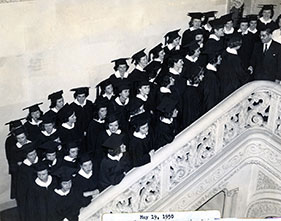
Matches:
[218,51,248,100]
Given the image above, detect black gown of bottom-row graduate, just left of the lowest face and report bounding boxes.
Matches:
[26,176,57,221]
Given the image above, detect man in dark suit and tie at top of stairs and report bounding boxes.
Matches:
[248,28,281,82]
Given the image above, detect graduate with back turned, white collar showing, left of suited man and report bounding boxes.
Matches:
[218,35,249,99]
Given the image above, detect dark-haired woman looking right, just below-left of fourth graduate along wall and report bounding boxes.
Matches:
[58,104,81,143]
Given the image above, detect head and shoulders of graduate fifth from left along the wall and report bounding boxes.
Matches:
[95,78,115,103]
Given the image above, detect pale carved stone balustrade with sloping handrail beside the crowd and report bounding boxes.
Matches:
[79,81,281,220]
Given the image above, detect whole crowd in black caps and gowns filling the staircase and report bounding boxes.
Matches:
[5,5,281,221]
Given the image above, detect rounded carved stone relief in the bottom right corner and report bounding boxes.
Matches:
[246,200,281,218]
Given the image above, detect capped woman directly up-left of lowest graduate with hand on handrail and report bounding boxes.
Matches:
[62,140,80,169]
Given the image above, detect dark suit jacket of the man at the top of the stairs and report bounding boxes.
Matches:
[250,40,281,81]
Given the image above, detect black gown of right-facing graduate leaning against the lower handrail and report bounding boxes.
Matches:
[99,153,131,191]
